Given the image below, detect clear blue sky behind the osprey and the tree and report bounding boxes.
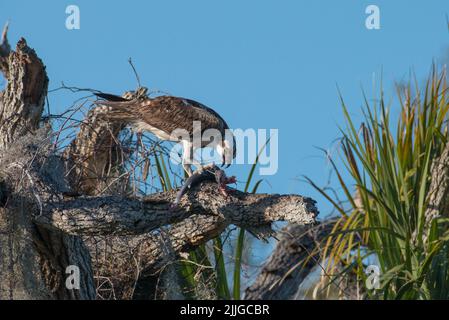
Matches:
[0,0,449,215]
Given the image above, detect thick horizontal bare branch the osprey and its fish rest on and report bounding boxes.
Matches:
[36,182,318,236]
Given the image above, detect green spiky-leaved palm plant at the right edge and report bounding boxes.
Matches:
[308,68,449,299]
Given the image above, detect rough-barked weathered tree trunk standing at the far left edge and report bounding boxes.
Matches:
[0,33,95,299]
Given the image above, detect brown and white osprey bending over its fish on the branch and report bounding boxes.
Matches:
[95,88,236,176]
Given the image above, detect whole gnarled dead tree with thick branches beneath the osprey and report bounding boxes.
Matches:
[0,31,318,299]
